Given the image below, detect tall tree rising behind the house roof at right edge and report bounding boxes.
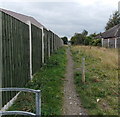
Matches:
[105,11,120,30]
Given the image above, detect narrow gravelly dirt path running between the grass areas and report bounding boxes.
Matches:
[63,48,87,115]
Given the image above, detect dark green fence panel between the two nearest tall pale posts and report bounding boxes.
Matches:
[31,25,42,74]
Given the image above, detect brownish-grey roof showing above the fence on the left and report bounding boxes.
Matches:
[0,8,47,29]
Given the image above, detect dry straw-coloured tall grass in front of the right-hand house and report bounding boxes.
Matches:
[73,46,118,69]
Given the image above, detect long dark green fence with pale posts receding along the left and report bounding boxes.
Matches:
[0,11,63,108]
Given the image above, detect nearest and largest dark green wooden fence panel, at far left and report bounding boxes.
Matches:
[2,13,30,106]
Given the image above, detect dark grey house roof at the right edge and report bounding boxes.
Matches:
[101,24,120,39]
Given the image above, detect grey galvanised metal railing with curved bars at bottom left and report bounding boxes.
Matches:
[0,88,41,117]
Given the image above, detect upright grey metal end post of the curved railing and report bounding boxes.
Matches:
[36,91,41,117]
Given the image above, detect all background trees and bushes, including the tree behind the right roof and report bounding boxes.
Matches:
[62,11,120,46]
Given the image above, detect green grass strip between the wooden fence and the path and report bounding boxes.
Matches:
[9,47,67,117]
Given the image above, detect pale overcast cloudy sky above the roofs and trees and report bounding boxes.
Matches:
[0,0,120,38]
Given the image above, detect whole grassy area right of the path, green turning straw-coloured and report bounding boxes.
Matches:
[71,46,119,115]
